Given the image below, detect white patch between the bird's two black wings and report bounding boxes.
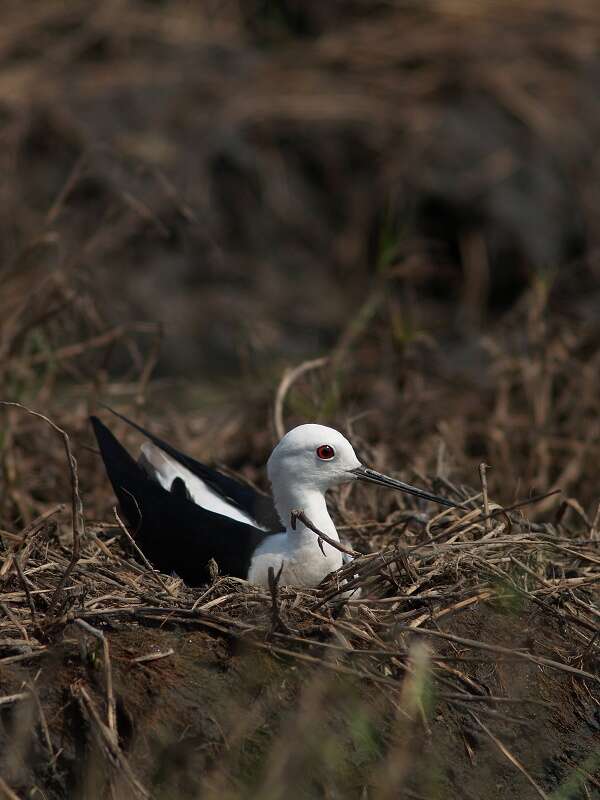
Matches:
[141,442,265,530]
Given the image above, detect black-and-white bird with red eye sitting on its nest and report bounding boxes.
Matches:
[90,409,456,587]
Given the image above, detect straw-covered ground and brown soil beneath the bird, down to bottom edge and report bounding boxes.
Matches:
[0,484,600,798]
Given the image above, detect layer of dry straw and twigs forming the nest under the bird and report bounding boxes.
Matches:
[0,396,600,797]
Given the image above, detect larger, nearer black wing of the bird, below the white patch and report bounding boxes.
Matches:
[90,417,269,586]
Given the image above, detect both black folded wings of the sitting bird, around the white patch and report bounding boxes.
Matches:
[91,415,282,586]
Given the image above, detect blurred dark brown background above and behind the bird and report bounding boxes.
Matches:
[0,0,600,512]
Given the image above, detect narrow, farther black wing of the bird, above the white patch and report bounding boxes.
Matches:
[107,406,284,532]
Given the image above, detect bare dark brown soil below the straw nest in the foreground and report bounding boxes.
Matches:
[0,604,600,800]
